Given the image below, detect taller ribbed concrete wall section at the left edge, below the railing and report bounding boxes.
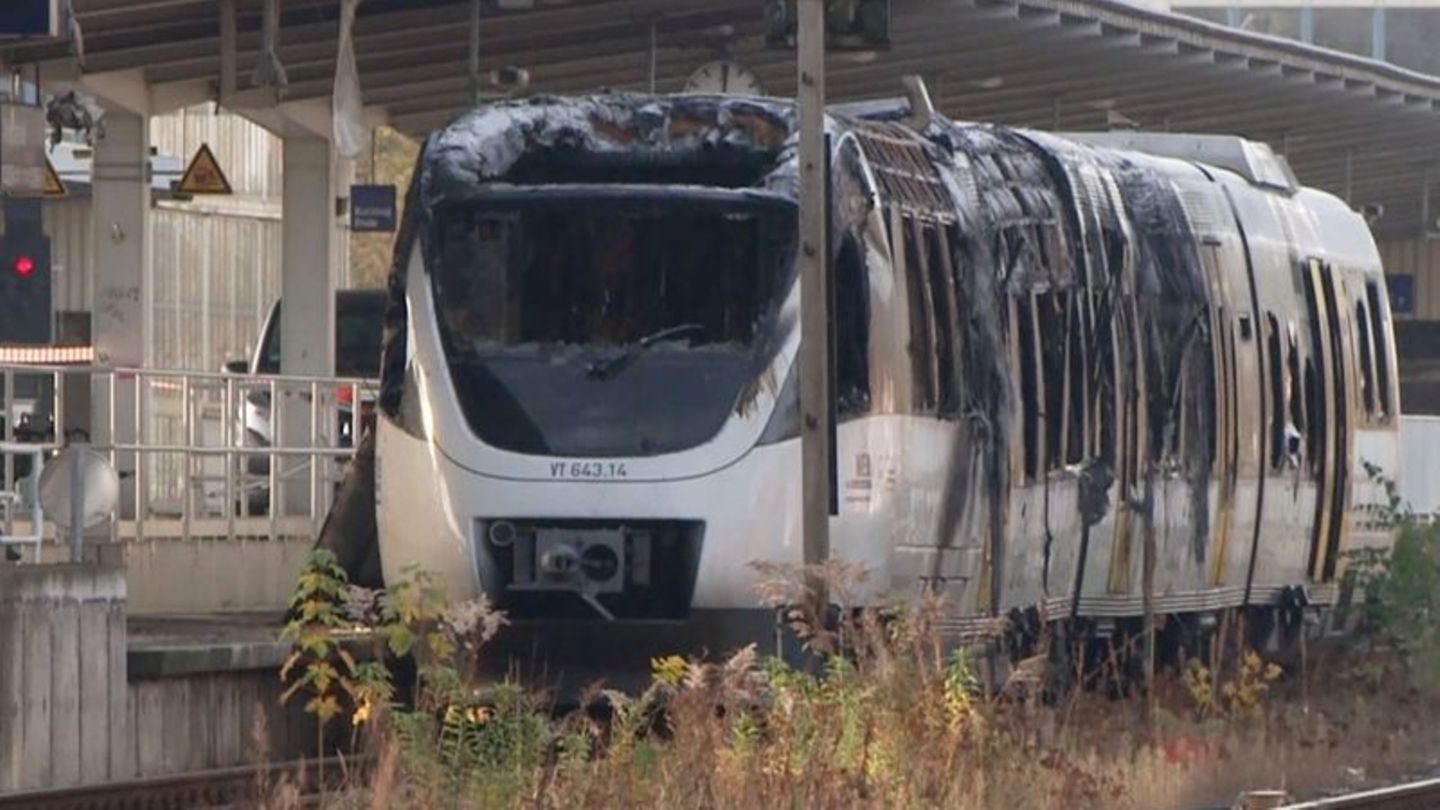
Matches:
[0,553,126,791]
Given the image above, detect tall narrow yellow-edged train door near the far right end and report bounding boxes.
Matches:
[1303,258,1354,582]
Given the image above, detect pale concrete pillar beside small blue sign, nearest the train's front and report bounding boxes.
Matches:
[275,137,337,515]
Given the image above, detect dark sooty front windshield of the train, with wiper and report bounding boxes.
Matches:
[431,192,795,457]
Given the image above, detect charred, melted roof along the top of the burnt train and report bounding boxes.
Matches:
[412,94,1364,242]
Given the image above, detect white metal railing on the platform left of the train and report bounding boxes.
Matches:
[0,365,377,553]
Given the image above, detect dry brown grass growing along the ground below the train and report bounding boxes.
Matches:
[271,553,1440,810]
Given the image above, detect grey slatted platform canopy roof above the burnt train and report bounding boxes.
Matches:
[8,0,1440,235]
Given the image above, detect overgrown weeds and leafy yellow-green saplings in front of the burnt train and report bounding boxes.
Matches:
[277,559,1440,810]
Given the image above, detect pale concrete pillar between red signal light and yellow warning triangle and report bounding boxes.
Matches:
[91,110,151,517]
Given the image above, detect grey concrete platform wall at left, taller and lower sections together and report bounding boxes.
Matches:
[0,553,315,793]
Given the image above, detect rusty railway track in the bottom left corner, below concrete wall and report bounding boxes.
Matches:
[0,758,364,810]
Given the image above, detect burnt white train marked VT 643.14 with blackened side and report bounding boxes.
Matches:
[357,85,1400,666]
